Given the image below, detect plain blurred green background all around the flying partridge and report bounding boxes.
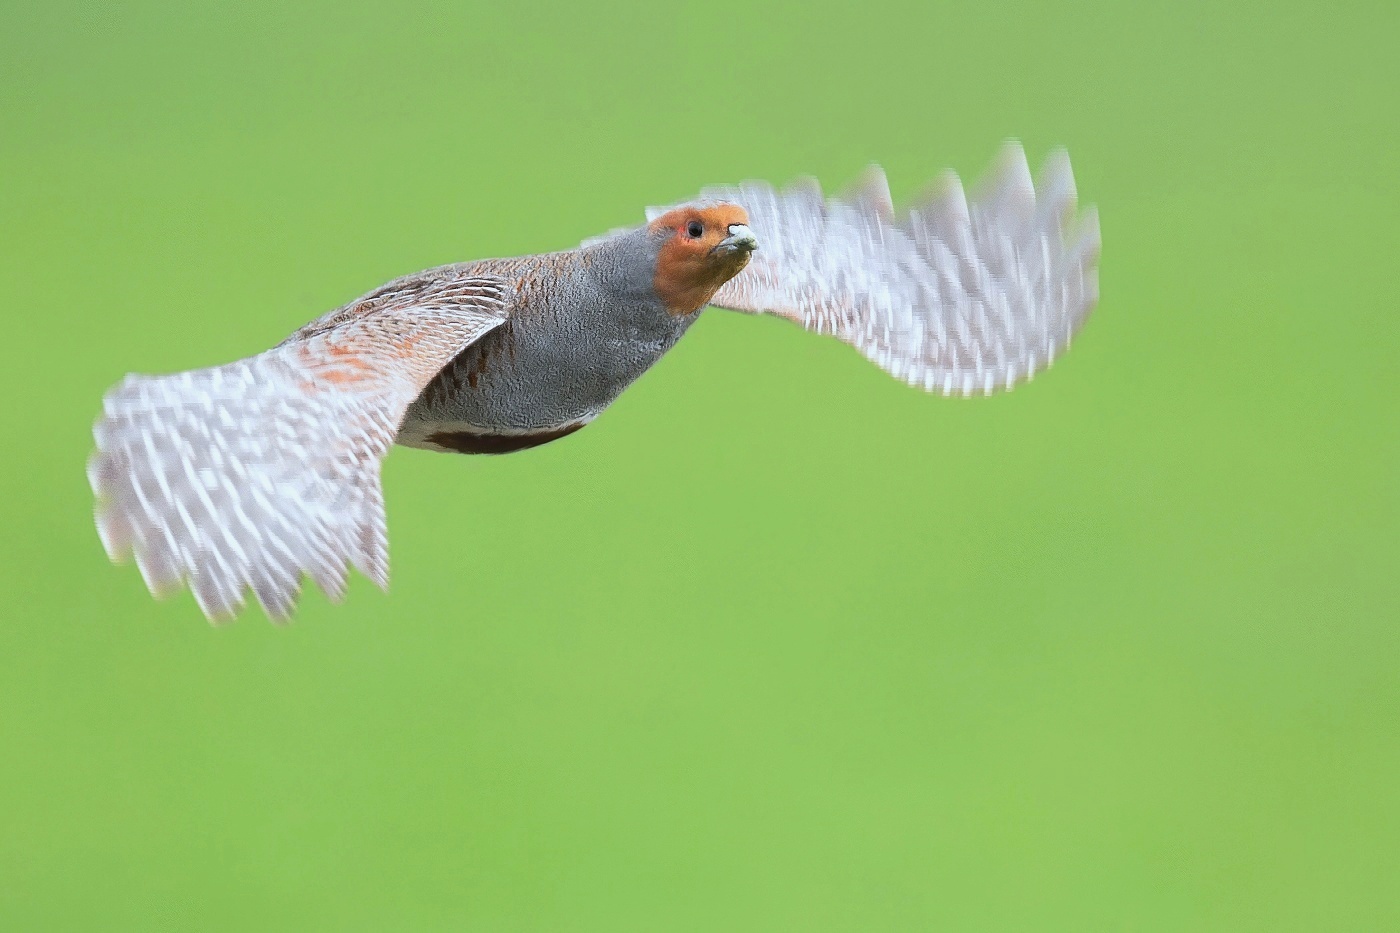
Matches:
[0,1,1400,930]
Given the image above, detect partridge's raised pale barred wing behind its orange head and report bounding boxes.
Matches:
[652,143,1099,395]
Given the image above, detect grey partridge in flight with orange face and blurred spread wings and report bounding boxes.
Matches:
[88,143,1099,622]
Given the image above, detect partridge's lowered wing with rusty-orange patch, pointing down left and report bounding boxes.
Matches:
[88,266,512,621]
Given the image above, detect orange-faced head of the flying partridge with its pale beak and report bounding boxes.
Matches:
[647,202,759,314]
